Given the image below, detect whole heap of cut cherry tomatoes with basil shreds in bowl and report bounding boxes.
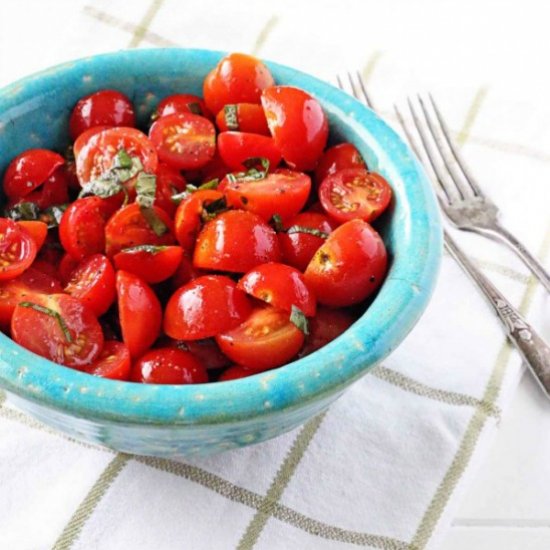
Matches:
[0,54,392,384]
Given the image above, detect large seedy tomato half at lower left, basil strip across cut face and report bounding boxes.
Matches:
[11,294,103,367]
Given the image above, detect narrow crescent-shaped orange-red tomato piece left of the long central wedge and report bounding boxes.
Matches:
[174,189,224,252]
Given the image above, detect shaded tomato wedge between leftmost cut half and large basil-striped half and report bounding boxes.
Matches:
[0,265,63,331]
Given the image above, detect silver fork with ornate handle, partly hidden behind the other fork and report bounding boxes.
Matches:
[337,73,550,398]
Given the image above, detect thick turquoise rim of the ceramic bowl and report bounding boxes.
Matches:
[0,48,442,425]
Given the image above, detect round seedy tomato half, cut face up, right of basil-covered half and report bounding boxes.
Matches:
[149,113,216,170]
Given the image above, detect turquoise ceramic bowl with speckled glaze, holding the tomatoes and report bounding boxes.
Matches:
[0,49,442,457]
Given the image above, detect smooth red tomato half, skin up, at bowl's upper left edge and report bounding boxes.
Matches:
[4,149,65,199]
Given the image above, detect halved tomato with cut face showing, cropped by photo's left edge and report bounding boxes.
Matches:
[0,218,37,281]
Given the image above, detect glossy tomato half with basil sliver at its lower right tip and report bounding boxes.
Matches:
[238,263,316,317]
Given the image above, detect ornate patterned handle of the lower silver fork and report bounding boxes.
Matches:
[445,232,550,398]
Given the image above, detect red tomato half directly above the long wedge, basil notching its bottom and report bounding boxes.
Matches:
[218,132,281,170]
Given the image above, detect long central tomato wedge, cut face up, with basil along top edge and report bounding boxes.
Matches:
[221,168,311,222]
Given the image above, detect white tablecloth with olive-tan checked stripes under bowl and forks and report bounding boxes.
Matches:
[0,0,550,550]
